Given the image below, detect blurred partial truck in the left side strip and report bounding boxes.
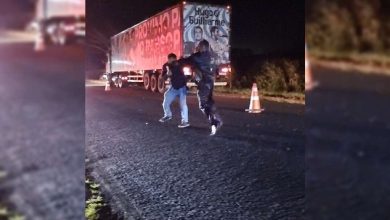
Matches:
[33,0,85,45]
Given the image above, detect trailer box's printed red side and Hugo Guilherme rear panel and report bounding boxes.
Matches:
[111,3,230,72]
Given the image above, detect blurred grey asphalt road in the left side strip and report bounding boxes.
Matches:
[0,43,85,220]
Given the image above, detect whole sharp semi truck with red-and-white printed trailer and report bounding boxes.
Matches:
[106,2,231,93]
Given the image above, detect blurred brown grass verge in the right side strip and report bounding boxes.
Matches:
[309,49,390,68]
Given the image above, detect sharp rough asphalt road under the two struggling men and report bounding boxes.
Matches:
[86,87,305,220]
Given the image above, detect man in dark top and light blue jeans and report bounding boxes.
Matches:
[159,53,190,128]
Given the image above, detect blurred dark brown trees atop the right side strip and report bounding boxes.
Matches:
[305,0,390,53]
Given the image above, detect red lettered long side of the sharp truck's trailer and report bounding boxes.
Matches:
[111,6,182,71]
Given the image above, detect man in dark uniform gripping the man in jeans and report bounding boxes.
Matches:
[185,40,222,135]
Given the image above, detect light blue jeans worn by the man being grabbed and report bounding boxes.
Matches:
[163,86,188,122]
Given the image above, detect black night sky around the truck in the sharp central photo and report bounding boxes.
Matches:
[86,0,305,69]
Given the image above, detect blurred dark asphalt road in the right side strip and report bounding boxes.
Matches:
[305,64,390,220]
